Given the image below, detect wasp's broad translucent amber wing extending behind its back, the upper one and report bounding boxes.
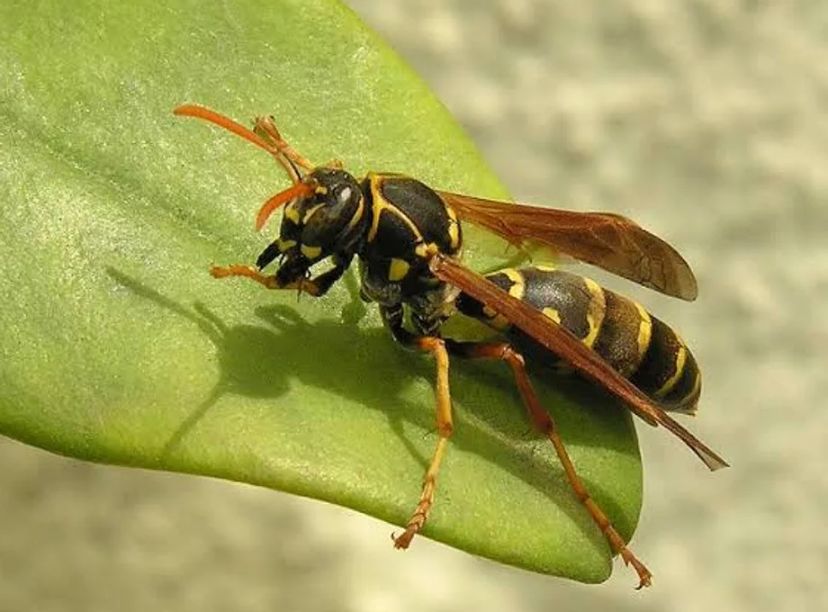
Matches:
[437,191,698,300]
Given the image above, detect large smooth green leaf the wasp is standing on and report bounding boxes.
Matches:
[0,0,641,581]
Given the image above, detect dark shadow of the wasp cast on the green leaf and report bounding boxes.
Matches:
[107,268,632,535]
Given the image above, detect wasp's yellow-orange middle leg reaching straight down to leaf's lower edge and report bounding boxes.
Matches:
[380,306,454,549]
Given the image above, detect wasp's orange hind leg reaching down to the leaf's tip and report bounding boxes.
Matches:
[445,340,652,589]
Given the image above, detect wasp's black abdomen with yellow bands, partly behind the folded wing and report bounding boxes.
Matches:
[457,267,701,413]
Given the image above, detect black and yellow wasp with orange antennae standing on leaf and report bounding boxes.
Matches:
[174,104,727,588]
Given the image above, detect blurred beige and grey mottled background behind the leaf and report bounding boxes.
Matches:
[0,0,828,612]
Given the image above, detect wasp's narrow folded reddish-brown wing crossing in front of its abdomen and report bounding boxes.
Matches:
[430,254,727,470]
